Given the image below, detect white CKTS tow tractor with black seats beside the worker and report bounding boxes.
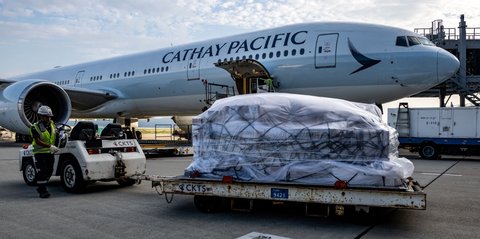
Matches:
[19,121,146,193]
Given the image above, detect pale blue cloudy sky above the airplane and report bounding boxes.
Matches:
[0,0,480,109]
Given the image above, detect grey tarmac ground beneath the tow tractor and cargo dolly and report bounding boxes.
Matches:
[0,142,480,239]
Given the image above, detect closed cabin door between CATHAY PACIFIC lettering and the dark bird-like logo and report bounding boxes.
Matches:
[315,33,338,68]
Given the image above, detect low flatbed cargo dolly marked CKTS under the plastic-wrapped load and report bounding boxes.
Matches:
[144,176,426,215]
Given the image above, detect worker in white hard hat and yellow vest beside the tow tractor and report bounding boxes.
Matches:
[30,105,58,198]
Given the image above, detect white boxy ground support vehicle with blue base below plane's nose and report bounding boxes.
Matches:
[388,103,480,159]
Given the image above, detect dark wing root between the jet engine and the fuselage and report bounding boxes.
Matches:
[63,86,118,110]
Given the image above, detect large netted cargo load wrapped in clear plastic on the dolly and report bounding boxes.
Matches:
[185,93,413,187]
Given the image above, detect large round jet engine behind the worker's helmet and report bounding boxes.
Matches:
[0,79,72,134]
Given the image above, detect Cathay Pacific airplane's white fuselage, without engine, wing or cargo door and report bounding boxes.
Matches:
[9,23,458,118]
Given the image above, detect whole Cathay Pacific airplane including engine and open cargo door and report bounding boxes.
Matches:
[0,22,459,134]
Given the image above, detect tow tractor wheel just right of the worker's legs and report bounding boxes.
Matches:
[60,159,86,193]
